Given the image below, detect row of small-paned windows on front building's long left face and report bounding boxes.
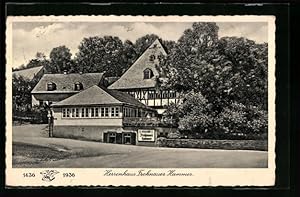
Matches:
[62,107,120,118]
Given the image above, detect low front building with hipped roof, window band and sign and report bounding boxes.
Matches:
[51,85,162,144]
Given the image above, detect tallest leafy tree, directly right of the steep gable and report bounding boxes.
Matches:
[161,23,227,107]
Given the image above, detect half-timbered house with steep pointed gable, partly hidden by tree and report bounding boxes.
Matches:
[108,39,178,114]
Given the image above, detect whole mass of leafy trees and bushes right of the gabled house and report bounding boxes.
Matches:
[160,23,268,138]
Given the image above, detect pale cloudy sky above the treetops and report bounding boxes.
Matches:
[12,22,268,68]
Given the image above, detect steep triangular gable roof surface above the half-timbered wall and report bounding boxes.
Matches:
[108,39,167,89]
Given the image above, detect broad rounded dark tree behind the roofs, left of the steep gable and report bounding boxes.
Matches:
[75,36,127,76]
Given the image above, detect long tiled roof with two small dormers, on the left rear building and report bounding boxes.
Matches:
[31,73,104,93]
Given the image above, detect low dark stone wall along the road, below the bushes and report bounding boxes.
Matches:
[156,138,268,151]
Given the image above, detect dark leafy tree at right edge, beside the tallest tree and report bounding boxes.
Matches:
[219,37,268,109]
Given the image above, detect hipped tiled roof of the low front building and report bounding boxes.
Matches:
[52,85,153,110]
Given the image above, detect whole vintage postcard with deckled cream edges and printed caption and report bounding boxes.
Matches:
[6,15,276,187]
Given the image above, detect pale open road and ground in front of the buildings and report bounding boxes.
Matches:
[13,125,268,168]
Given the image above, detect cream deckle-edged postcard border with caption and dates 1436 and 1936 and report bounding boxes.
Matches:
[6,15,276,186]
